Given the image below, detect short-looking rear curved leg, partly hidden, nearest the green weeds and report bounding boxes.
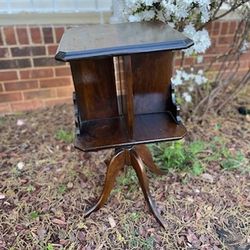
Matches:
[134,145,167,175]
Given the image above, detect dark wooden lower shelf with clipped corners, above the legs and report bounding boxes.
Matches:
[75,112,186,151]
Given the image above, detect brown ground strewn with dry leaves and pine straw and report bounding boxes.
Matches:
[0,100,250,250]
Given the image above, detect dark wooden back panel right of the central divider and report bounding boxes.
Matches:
[131,51,173,114]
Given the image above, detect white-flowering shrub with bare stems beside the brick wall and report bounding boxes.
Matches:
[114,0,250,117]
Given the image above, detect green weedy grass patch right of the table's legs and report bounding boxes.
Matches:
[151,137,249,175]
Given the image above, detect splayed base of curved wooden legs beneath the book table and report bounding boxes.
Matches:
[84,145,168,228]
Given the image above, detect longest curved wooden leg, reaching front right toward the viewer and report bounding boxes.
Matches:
[130,149,165,228]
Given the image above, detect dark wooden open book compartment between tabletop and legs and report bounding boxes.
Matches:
[71,52,186,151]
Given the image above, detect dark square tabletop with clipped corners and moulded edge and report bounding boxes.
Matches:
[56,22,193,61]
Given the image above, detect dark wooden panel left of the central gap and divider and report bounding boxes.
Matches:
[70,58,118,121]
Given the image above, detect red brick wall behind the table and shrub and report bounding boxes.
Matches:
[0,20,250,113]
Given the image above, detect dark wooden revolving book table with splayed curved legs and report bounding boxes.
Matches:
[56,22,193,229]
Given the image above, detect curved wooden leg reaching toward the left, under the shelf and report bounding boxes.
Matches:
[84,151,126,218]
